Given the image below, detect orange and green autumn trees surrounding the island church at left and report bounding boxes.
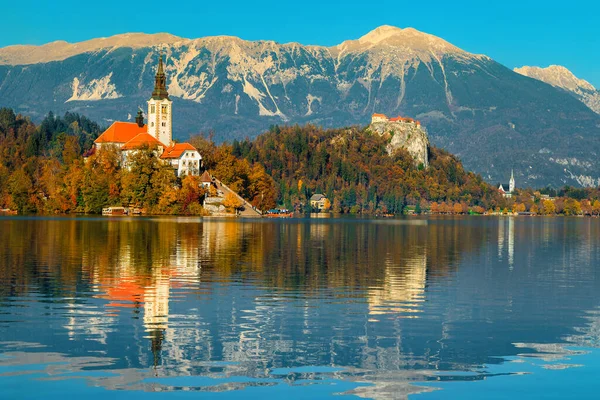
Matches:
[0,108,275,215]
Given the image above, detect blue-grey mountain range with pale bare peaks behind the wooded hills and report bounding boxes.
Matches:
[0,26,600,187]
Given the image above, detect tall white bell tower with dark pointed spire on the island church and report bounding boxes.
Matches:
[148,54,173,146]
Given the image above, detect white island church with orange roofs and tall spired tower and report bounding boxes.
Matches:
[84,55,202,176]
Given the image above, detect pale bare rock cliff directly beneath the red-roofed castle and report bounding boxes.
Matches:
[369,121,429,168]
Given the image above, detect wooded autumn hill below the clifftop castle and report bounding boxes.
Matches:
[231,125,505,214]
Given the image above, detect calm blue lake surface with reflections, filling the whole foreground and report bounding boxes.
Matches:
[0,217,600,400]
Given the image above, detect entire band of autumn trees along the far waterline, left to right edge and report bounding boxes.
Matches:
[0,108,600,215]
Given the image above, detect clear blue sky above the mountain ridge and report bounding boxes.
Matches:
[0,0,600,88]
